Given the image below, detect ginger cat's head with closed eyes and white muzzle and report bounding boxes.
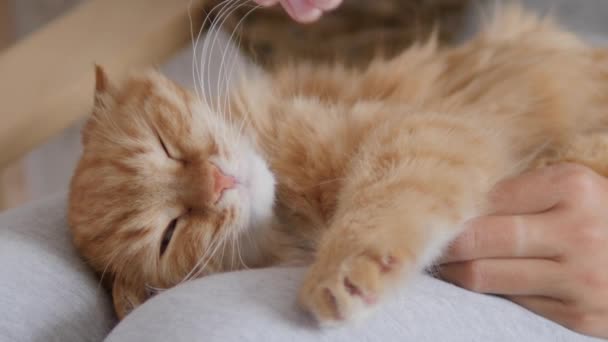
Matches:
[69,67,274,318]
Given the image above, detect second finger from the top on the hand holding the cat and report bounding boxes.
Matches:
[440,214,562,263]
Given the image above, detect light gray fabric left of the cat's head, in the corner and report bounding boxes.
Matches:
[0,196,115,342]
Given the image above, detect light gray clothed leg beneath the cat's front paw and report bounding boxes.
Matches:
[107,268,599,342]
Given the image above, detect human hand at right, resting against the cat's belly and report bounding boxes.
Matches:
[440,164,608,338]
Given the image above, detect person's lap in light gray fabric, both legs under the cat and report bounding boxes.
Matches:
[0,196,592,342]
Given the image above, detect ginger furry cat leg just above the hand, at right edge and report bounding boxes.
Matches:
[533,132,608,177]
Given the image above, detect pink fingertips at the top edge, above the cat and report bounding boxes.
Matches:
[254,0,342,23]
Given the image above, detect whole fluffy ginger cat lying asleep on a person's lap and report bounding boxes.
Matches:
[69,7,608,325]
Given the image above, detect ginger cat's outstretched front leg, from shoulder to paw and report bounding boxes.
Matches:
[299,115,509,325]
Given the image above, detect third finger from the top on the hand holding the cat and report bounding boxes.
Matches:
[439,259,565,298]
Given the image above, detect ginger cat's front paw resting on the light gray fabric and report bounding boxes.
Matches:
[299,249,404,326]
